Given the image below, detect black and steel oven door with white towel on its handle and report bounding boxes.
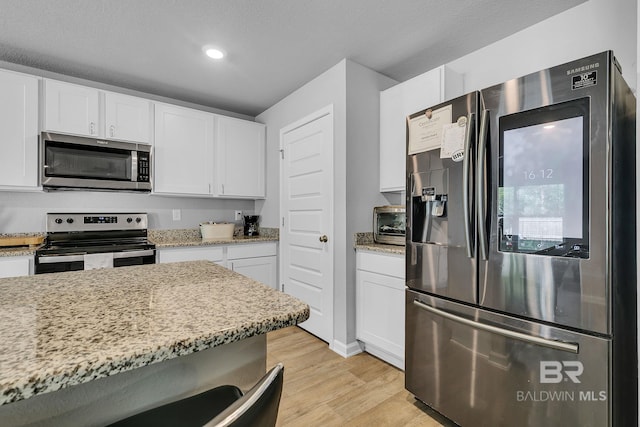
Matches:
[34,249,156,274]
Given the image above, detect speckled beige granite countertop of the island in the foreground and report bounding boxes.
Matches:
[0,261,309,404]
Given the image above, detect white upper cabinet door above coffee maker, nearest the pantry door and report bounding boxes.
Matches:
[215,116,266,199]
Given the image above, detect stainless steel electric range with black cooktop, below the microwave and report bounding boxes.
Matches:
[35,213,156,274]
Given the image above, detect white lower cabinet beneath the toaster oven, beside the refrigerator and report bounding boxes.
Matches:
[356,251,405,370]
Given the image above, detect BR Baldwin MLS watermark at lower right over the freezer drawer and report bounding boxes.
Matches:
[516,360,607,402]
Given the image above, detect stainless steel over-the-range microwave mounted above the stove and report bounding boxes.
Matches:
[39,132,152,192]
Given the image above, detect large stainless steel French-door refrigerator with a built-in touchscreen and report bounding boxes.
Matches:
[405,52,638,427]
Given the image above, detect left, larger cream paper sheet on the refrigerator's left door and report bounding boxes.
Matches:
[407,105,451,155]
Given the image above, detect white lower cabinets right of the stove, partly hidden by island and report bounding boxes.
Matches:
[158,242,278,289]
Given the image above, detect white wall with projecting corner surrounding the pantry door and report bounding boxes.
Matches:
[256,60,395,353]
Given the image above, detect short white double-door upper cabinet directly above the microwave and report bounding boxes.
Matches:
[42,79,152,144]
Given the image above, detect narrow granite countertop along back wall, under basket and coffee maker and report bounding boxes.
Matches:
[149,227,279,248]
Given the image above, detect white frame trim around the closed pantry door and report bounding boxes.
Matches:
[278,104,335,348]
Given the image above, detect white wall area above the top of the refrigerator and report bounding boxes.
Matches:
[448,0,637,92]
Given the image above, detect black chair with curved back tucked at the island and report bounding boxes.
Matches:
[109,363,284,427]
